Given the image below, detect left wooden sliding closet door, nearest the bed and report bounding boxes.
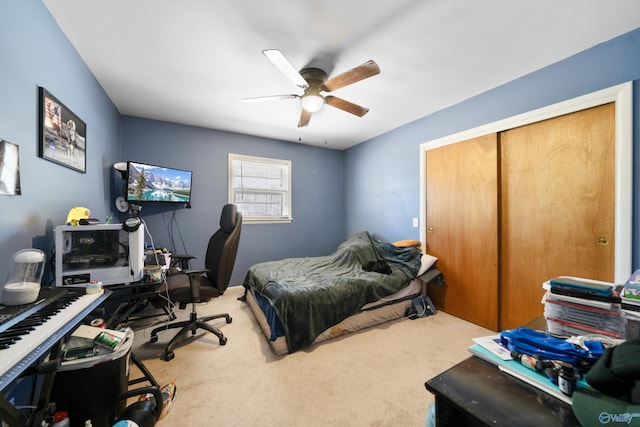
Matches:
[426,134,498,333]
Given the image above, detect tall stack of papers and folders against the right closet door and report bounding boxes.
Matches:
[542,276,627,339]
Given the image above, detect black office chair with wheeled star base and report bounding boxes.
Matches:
[150,204,242,361]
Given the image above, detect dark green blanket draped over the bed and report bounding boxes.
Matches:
[244,232,420,353]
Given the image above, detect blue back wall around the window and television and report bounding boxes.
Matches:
[120,117,344,285]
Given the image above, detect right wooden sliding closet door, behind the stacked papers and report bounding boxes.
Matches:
[500,104,615,329]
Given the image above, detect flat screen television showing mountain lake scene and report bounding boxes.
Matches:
[127,161,193,205]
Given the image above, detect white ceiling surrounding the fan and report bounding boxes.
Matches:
[43,0,640,149]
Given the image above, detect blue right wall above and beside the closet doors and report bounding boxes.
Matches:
[344,29,640,268]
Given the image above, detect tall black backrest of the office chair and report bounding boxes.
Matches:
[204,204,242,294]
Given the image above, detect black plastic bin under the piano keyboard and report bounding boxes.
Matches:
[51,328,133,427]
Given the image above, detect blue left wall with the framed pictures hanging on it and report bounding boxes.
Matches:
[0,0,120,283]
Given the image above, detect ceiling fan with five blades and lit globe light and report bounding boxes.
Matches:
[243,49,380,127]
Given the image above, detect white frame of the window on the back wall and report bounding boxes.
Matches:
[227,153,293,224]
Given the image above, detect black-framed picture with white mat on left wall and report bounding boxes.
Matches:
[38,87,87,173]
